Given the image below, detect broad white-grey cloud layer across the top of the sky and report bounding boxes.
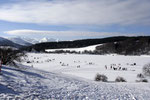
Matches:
[0,0,150,25]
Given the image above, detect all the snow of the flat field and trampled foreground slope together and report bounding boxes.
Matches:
[0,53,150,100]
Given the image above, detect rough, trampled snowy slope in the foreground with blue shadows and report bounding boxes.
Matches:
[0,67,150,100]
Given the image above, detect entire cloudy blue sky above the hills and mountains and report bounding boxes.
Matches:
[0,0,150,40]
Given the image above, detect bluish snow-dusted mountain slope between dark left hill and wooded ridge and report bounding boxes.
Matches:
[8,37,32,46]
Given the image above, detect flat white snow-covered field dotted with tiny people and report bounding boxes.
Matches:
[23,53,150,83]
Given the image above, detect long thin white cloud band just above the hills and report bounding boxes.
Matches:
[5,29,145,37]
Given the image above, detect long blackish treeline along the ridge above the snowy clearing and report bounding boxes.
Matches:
[23,36,130,52]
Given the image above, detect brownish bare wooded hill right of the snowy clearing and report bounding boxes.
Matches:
[96,36,150,55]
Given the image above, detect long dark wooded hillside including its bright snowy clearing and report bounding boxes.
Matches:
[24,36,150,55]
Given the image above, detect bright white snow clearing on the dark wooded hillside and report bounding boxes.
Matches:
[45,44,102,52]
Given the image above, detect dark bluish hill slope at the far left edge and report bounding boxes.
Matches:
[0,37,23,48]
